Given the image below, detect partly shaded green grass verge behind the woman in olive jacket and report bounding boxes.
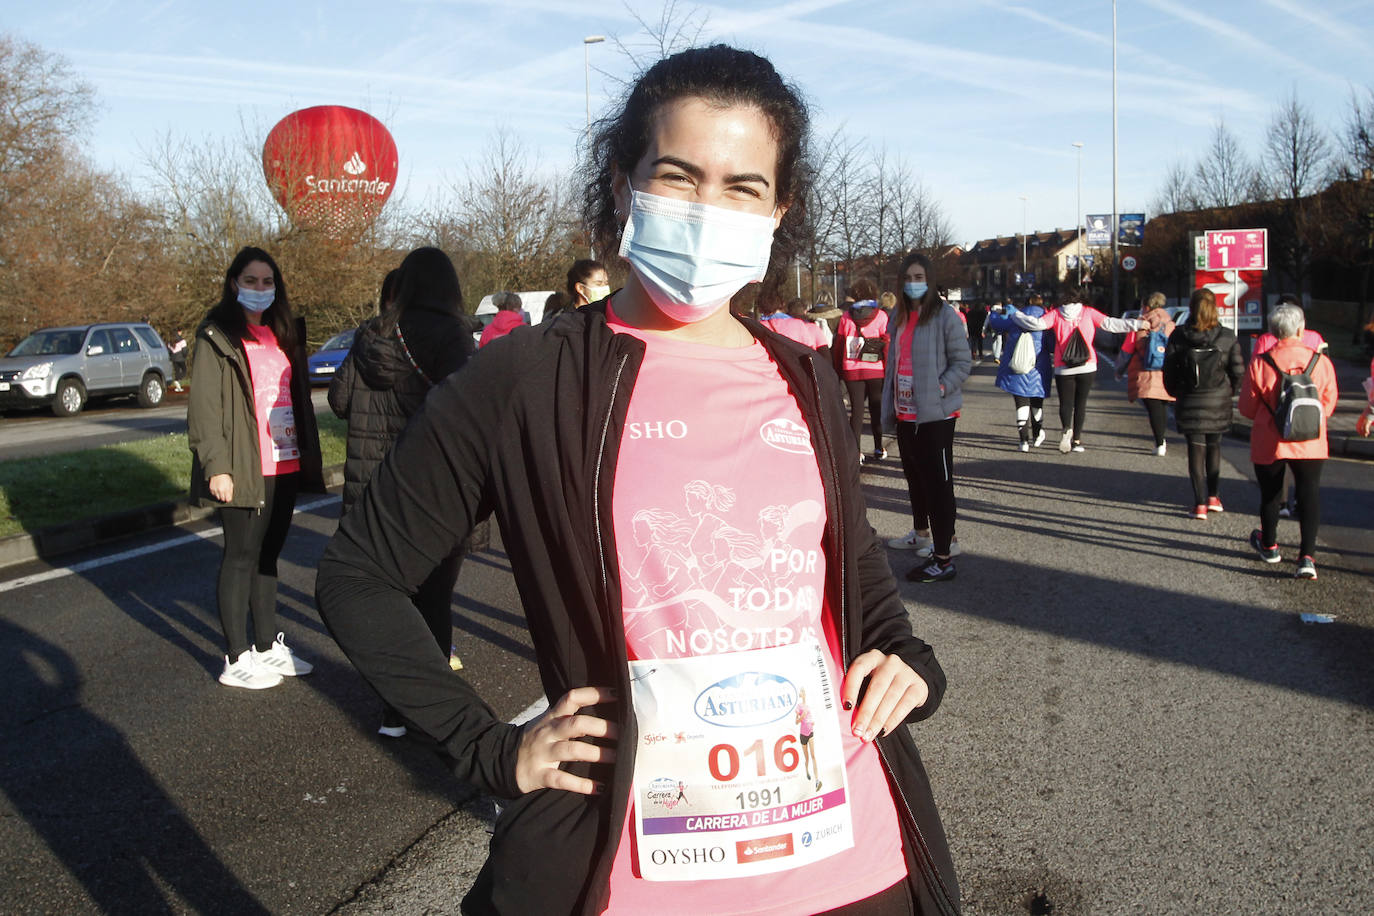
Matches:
[0,411,348,537]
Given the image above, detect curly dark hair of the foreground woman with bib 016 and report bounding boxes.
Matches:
[583,44,812,284]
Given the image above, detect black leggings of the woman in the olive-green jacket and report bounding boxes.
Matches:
[218,474,300,662]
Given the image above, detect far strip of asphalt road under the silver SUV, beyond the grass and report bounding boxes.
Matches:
[0,387,328,461]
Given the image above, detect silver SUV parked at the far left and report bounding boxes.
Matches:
[0,321,172,416]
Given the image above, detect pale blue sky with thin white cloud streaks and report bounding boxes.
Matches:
[10,0,1374,242]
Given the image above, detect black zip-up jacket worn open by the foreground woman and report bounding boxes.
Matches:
[316,304,959,916]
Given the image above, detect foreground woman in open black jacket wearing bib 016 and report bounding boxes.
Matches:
[317,45,958,913]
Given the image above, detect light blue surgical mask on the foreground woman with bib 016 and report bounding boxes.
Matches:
[620,190,774,324]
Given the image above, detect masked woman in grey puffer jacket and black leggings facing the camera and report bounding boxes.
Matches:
[882,253,973,582]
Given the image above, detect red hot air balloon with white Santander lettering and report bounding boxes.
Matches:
[262,104,397,239]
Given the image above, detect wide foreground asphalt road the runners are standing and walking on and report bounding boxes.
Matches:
[0,365,1374,916]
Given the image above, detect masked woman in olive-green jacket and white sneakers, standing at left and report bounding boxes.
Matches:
[185,247,324,689]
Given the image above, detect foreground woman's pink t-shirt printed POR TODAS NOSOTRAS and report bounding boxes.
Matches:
[607,308,907,916]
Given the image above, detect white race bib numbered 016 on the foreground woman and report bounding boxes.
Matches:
[629,640,853,880]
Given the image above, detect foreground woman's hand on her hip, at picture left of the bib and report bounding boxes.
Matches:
[515,687,620,795]
